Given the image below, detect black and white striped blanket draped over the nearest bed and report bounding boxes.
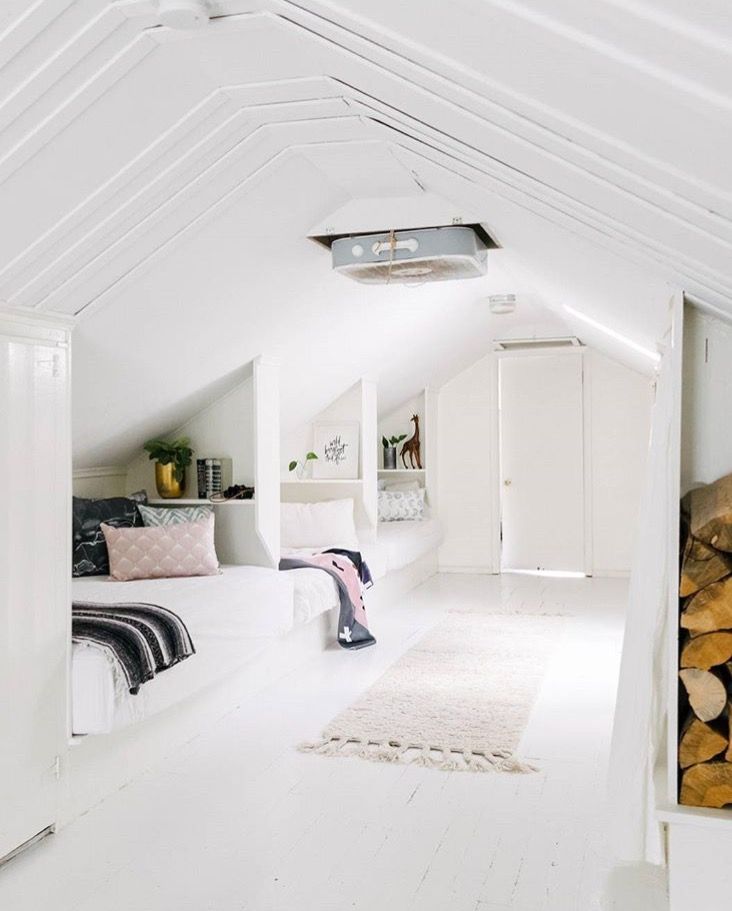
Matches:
[71,601,196,694]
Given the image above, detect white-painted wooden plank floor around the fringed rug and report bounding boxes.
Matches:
[0,575,627,911]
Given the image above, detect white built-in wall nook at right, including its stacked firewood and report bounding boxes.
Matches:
[660,302,732,909]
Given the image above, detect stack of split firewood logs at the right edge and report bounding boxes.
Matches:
[678,475,732,807]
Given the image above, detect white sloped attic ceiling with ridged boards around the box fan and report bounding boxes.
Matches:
[0,0,732,465]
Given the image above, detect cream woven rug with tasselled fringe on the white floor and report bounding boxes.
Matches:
[300,613,564,772]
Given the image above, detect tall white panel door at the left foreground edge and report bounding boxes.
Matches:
[0,314,70,858]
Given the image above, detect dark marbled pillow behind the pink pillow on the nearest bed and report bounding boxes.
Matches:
[71,490,147,576]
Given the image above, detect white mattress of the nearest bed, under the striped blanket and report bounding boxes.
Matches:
[71,566,294,734]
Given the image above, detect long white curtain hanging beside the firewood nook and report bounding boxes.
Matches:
[609,326,681,864]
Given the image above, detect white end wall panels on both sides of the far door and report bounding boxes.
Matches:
[438,350,652,575]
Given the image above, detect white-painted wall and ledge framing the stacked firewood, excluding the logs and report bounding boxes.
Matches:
[660,304,732,911]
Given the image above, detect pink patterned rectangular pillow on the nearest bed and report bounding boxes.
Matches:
[102,513,219,582]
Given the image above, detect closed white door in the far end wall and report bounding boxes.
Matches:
[499,353,585,572]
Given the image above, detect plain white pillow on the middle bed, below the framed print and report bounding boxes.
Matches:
[280,499,358,550]
